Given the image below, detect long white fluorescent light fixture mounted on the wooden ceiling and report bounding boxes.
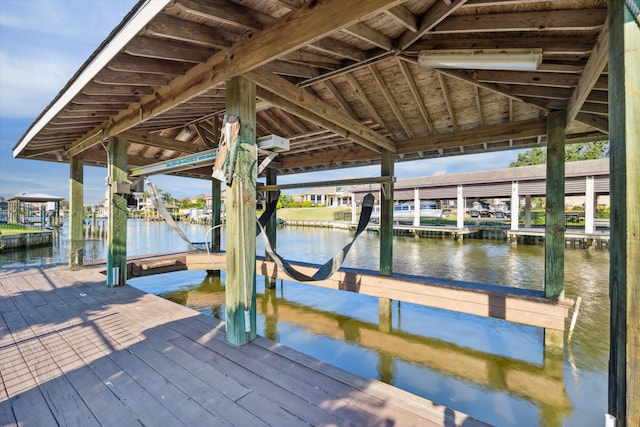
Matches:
[418,49,542,71]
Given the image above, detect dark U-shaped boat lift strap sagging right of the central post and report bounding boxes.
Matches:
[258,193,374,282]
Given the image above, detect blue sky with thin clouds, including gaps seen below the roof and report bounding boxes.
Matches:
[0,0,520,203]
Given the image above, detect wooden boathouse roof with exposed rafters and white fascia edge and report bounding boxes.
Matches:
[14,0,608,179]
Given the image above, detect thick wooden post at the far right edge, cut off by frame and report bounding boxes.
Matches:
[607,0,640,427]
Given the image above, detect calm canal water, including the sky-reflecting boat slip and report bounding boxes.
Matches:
[0,220,609,427]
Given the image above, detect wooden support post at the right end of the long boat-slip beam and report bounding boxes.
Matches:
[544,111,566,299]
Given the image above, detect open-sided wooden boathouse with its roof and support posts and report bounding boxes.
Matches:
[7,0,640,426]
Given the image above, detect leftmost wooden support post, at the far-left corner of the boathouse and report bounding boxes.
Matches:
[68,155,84,269]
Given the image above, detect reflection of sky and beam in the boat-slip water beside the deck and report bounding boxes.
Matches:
[133,252,604,426]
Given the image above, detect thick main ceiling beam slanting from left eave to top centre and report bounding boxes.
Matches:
[69,0,402,155]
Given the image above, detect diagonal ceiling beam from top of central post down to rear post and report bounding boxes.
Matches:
[245,70,395,152]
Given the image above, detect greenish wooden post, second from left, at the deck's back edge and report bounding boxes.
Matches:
[107,137,128,287]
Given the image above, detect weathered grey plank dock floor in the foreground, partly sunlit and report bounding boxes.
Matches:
[0,266,486,427]
